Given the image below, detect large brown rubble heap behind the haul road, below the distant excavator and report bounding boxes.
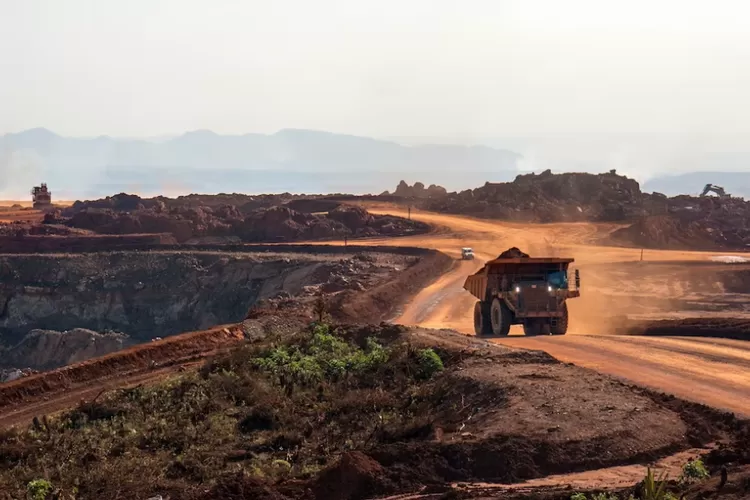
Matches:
[388,170,750,250]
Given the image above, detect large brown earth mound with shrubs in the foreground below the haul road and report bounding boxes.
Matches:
[0,325,745,500]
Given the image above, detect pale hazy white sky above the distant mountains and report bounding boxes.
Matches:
[0,0,750,142]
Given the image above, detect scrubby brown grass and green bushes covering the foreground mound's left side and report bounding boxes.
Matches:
[0,323,464,500]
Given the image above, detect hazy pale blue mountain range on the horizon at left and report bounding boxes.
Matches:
[0,128,520,199]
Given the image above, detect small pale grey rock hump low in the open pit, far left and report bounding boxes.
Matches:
[0,328,132,370]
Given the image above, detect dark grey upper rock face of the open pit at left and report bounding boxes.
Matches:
[0,252,323,346]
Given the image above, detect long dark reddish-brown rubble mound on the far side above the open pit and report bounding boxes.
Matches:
[55,194,428,243]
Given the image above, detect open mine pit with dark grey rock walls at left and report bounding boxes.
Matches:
[0,249,426,369]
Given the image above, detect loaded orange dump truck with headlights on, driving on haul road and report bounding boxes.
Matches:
[464,257,580,335]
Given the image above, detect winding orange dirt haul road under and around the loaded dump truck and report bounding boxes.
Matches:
[334,205,750,416]
